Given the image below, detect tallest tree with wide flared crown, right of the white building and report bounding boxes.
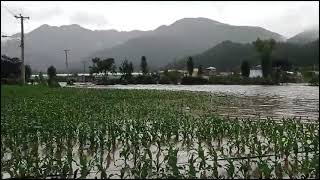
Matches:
[253,38,276,78]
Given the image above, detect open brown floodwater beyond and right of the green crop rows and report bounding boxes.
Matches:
[69,83,319,120]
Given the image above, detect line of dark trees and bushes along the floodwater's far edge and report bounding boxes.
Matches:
[1,38,318,86]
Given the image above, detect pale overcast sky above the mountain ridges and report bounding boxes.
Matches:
[1,1,319,37]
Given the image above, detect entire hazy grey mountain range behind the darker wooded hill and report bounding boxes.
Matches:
[1,18,313,71]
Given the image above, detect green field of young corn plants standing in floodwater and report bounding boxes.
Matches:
[1,86,319,178]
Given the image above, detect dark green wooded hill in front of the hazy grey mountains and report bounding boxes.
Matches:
[164,39,319,71]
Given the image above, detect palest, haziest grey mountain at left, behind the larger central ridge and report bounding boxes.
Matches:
[1,24,144,71]
